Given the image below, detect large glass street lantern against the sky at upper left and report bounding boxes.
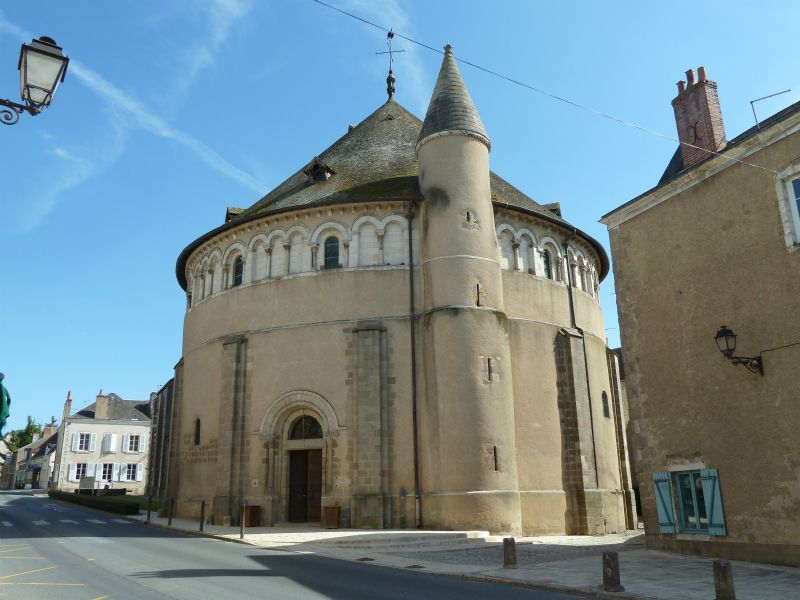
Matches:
[0,36,69,125]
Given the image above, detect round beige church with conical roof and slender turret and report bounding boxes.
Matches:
[166,47,634,534]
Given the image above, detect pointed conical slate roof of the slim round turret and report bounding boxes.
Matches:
[417,44,491,149]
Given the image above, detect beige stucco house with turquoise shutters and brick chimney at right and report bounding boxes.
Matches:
[602,68,800,565]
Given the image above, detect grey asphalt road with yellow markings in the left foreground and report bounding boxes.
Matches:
[0,492,578,600]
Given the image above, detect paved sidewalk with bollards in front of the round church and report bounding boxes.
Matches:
[131,514,800,600]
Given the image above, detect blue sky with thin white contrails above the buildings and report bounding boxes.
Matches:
[0,0,800,428]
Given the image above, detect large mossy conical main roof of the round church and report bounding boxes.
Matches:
[175,96,608,289]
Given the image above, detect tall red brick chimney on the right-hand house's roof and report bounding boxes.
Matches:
[672,67,728,169]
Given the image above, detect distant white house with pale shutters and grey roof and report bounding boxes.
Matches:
[51,390,150,494]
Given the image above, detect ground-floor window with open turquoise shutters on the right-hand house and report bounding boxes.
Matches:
[653,469,727,536]
